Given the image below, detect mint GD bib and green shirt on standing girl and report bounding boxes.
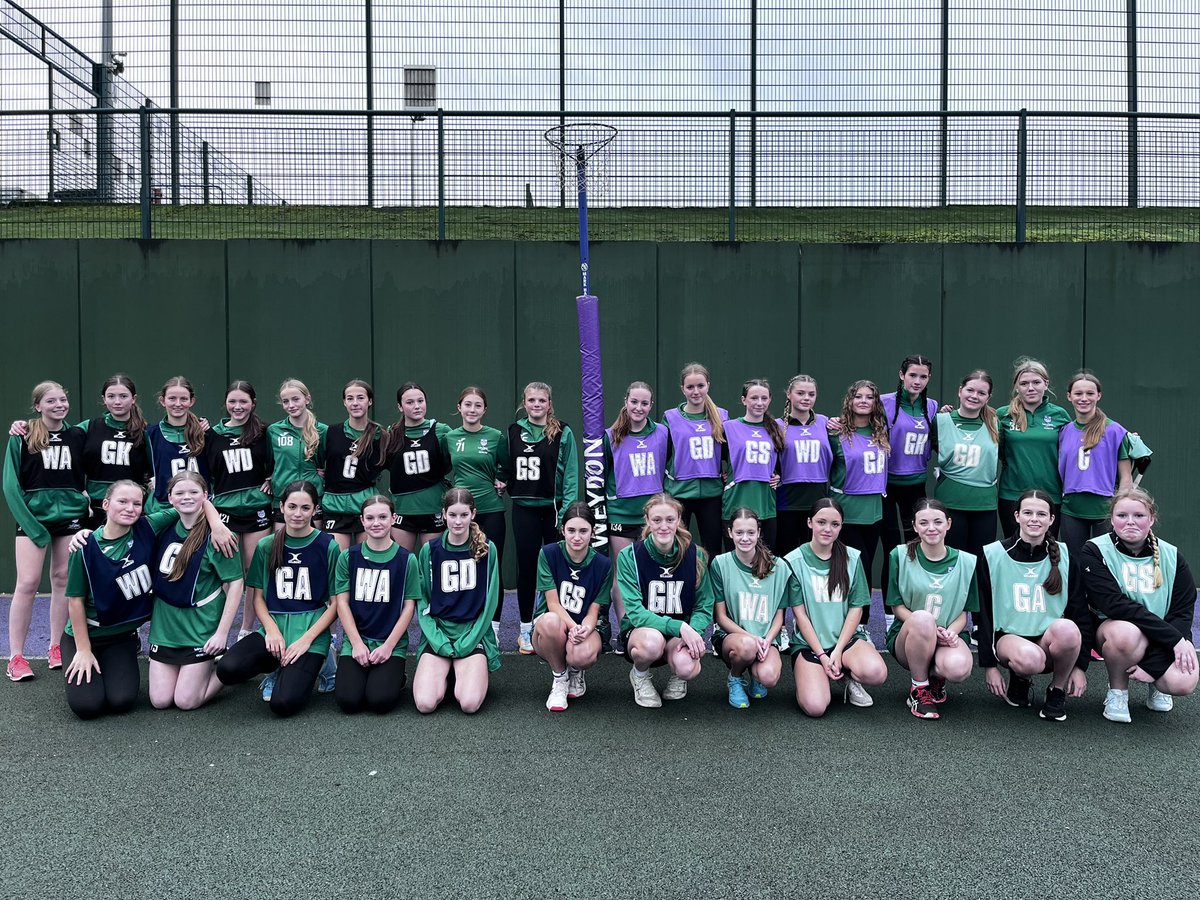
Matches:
[934,410,1000,512]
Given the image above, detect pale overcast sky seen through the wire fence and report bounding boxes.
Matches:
[7,0,1200,205]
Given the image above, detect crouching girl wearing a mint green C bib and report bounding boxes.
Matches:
[884,498,979,719]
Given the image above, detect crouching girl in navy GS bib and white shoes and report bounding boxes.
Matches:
[533,500,612,712]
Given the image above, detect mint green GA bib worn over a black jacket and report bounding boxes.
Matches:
[983,541,1070,637]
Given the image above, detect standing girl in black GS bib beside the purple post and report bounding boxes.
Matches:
[508,382,580,654]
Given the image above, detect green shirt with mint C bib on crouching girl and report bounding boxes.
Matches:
[887,544,979,652]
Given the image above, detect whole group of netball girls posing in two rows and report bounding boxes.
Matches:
[5,356,1194,718]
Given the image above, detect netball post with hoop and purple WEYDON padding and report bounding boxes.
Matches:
[545,122,617,548]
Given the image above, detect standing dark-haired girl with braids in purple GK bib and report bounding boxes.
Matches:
[880,353,937,595]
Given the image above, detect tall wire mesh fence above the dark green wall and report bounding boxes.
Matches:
[0,0,1200,240]
